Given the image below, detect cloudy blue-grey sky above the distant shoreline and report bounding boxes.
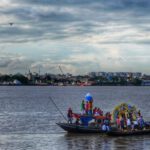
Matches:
[0,0,150,74]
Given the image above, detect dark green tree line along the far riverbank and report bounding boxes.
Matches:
[0,74,142,86]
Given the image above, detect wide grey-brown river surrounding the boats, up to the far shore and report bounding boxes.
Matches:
[0,86,150,150]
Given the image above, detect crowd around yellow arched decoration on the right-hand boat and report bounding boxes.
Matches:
[112,103,150,131]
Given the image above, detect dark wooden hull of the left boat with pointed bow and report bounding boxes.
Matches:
[56,123,105,133]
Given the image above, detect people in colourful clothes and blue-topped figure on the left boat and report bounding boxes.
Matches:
[67,95,111,130]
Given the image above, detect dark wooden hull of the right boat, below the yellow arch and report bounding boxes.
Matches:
[107,129,150,136]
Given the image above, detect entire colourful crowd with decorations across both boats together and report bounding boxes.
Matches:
[67,95,149,131]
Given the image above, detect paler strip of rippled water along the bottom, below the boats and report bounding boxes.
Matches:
[0,133,150,150]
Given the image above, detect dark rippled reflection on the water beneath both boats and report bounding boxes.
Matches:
[57,133,150,150]
